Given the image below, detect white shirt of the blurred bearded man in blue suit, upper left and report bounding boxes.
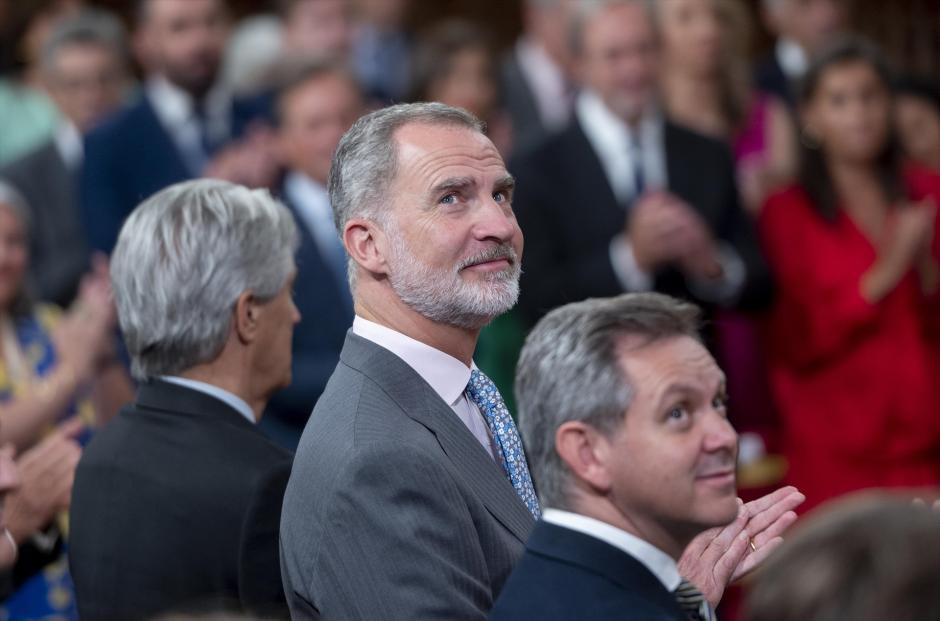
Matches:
[145,75,232,176]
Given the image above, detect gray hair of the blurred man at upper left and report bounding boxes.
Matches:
[40,9,128,77]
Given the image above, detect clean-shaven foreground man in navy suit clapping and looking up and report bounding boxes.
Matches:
[490,293,803,621]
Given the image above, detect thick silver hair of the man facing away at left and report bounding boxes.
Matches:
[111,179,299,380]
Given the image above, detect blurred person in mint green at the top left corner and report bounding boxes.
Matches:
[0,0,84,165]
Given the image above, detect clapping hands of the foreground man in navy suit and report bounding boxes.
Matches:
[679,487,806,607]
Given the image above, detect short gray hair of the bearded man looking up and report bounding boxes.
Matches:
[327,103,484,287]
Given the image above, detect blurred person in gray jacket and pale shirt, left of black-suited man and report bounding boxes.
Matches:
[501,0,576,151]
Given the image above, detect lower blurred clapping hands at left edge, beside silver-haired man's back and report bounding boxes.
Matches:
[4,419,84,543]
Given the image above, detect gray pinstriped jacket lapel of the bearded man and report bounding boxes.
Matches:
[340,331,533,543]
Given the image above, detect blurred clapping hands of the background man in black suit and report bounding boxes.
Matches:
[627,192,721,278]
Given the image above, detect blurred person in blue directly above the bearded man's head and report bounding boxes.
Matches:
[352,0,414,104]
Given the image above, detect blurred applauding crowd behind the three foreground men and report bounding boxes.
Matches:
[0,0,940,619]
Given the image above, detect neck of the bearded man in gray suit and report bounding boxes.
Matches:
[356,296,480,367]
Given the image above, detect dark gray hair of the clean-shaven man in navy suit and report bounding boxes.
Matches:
[515,293,699,509]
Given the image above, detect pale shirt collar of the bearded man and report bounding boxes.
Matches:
[353,315,476,406]
